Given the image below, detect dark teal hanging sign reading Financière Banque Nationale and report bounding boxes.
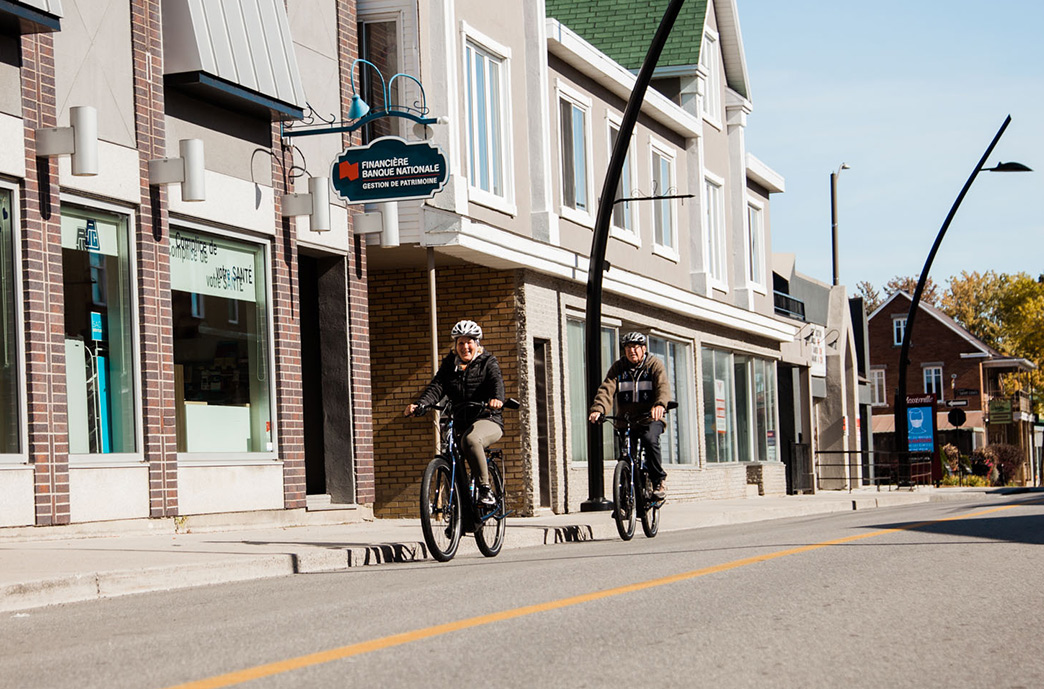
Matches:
[330,137,449,204]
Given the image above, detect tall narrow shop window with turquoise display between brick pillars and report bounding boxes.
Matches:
[62,206,137,454]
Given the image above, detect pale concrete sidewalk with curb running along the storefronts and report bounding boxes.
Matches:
[0,488,1001,611]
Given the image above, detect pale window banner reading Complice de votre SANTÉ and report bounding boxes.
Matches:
[170,231,257,302]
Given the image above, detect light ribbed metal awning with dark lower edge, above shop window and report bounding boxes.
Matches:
[163,0,305,118]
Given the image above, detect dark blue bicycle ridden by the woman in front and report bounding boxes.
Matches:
[413,399,521,563]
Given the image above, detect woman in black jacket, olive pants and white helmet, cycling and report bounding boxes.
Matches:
[403,320,504,505]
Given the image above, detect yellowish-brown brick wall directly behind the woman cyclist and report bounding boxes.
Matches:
[370,264,526,518]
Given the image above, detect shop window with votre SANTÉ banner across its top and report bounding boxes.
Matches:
[170,230,272,452]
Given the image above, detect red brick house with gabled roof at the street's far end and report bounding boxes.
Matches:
[869,291,1036,473]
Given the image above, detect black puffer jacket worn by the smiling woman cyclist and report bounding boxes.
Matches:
[417,351,504,432]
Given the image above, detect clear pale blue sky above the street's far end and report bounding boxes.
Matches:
[737,0,1044,291]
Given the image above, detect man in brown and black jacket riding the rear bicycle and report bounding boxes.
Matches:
[588,332,670,500]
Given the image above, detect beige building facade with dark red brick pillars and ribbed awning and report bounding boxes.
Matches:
[0,0,375,526]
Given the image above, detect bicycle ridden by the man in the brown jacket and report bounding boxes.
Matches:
[598,402,678,541]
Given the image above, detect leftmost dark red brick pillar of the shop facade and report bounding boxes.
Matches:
[19,33,69,525]
